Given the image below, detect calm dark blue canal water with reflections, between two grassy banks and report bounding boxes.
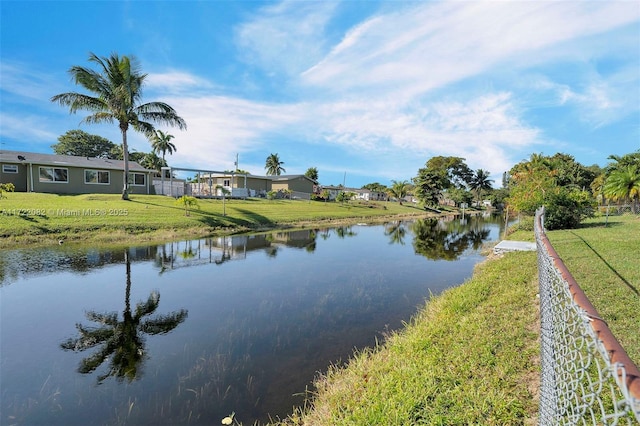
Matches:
[0,217,508,425]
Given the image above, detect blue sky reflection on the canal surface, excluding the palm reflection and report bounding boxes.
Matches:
[0,218,504,424]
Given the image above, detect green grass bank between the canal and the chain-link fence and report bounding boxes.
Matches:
[282,252,539,425]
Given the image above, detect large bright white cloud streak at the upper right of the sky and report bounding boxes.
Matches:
[303,2,640,97]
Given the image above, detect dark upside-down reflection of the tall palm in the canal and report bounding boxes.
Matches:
[60,251,187,383]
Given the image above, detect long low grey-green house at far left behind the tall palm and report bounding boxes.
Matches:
[0,150,154,194]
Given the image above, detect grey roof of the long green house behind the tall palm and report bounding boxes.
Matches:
[0,150,153,172]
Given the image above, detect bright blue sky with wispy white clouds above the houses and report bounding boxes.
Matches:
[0,0,640,187]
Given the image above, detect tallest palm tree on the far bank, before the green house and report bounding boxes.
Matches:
[51,53,187,200]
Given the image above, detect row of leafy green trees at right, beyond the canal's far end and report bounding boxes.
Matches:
[363,150,640,229]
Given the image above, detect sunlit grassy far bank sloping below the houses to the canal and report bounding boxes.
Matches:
[0,193,440,248]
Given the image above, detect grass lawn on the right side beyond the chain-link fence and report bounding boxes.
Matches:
[547,215,640,365]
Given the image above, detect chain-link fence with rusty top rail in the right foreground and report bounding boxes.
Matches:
[535,209,640,426]
